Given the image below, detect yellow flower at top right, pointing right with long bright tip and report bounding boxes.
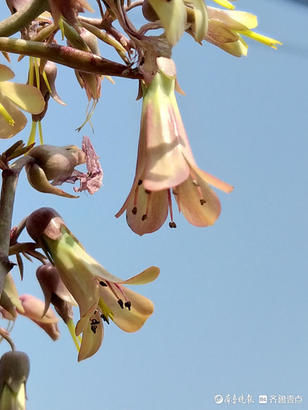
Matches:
[205,7,281,57]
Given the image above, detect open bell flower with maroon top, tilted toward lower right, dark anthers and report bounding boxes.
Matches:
[26,208,159,360]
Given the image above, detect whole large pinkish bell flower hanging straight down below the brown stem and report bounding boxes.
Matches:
[116,57,232,235]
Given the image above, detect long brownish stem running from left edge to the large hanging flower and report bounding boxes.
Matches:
[0,38,142,79]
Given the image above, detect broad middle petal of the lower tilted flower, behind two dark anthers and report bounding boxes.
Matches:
[100,287,154,332]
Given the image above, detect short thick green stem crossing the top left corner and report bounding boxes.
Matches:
[0,0,48,37]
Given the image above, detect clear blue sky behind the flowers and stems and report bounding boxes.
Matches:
[0,0,308,410]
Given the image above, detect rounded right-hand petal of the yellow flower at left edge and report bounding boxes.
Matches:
[0,81,45,114]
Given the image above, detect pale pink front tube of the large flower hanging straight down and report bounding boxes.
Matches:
[138,72,189,191]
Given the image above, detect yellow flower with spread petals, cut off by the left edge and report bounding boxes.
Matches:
[0,64,45,138]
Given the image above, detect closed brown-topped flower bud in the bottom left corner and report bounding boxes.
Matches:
[0,351,30,410]
